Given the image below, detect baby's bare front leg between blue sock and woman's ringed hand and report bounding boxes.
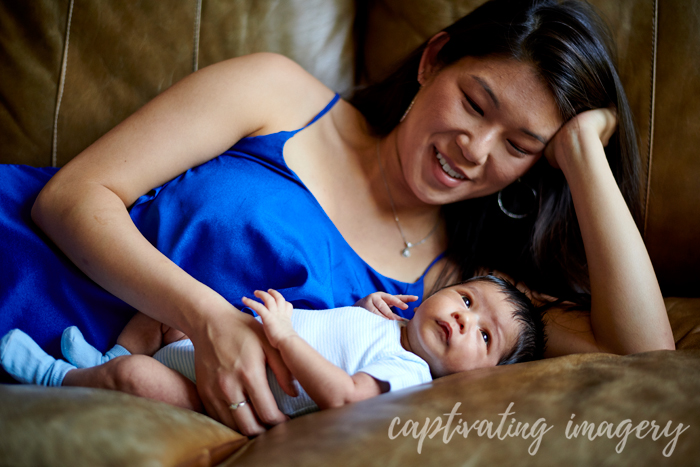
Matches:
[63,355,204,412]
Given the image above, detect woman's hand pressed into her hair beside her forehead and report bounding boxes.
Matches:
[544,108,617,168]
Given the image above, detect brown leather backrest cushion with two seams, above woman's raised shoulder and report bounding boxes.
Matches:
[0,0,355,166]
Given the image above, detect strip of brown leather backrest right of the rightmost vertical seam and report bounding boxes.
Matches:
[645,0,700,297]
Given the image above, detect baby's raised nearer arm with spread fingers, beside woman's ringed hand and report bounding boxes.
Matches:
[243,289,389,410]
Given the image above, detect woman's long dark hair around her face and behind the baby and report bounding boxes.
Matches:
[352,0,641,306]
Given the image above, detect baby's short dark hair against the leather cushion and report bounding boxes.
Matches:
[454,275,547,365]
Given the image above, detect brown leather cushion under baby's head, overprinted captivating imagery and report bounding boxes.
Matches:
[227,350,700,467]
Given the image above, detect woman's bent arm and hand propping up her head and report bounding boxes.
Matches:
[545,109,675,355]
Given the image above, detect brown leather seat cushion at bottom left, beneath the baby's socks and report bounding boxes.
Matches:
[0,385,247,466]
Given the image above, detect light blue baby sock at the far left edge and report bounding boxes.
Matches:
[0,329,75,386]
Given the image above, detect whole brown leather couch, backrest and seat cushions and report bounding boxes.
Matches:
[0,0,700,466]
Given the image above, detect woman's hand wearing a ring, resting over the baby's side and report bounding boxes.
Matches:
[190,306,296,436]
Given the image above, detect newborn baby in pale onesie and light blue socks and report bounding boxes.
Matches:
[0,276,545,417]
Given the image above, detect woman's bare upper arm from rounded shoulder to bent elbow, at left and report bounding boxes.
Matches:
[43,53,340,206]
